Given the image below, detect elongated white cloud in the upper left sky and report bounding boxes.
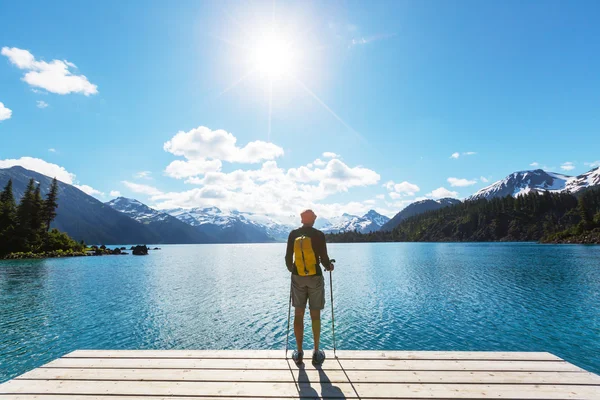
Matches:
[1,47,98,96]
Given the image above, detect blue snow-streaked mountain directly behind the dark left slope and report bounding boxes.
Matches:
[106,197,214,244]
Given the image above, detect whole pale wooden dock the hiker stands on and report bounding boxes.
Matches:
[0,350,600,400]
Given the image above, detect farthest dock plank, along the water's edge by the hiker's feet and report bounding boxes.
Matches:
[63,350,561,361]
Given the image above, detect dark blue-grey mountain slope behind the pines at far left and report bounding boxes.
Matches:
[0,167,160,244]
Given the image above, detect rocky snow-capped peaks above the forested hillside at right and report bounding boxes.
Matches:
[467,167,600,200]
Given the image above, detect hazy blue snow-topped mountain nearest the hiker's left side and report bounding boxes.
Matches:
[165,207,274,243]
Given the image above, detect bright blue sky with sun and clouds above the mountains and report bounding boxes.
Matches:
[0,0,600,216]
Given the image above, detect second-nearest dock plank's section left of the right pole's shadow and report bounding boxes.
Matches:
[15,366,349,383]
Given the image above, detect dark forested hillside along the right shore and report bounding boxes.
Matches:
[327,189,600,244]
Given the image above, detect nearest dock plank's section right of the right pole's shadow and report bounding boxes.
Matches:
[354,383,600,399]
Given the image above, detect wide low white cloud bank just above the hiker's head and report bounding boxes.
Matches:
[154,159,380,217]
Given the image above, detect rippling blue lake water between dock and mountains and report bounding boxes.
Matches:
[0,243,600,382]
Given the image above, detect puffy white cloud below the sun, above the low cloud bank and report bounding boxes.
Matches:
[163,126,283,163]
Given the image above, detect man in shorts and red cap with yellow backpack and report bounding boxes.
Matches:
[285,210,334,365]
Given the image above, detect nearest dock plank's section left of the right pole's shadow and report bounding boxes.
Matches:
[0,380,356,398]
